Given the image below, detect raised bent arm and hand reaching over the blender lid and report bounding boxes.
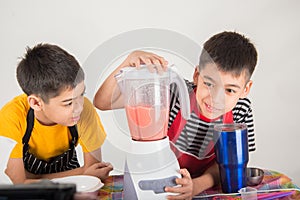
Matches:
[94,51,168,110]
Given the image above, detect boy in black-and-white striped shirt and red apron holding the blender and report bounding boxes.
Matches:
[94,32,257,199]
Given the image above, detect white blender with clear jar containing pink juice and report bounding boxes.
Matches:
[115,66,190,200]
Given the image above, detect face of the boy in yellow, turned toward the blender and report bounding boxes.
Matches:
[28,81,85,126]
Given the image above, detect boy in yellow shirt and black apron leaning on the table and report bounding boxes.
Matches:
[0,44,112,184]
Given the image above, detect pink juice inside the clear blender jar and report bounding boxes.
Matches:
[125,105,169,141]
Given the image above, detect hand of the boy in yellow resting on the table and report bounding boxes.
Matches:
[84,162,113,180]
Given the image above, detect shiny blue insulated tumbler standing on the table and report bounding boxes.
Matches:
[213,123,249,193]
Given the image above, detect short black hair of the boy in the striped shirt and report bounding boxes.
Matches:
[199,31,257,80]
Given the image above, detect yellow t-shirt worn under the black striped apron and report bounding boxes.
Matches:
[0,94,106,161]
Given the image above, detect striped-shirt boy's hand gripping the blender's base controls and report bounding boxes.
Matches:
[165,169,193,199]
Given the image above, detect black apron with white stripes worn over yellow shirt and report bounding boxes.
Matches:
[22,108,80,174]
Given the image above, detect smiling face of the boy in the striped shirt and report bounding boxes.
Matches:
[194,63,252,119]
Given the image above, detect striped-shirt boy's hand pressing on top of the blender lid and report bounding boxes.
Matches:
[123,51,168,73]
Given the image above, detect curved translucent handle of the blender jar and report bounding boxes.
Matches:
[171,68,191,120]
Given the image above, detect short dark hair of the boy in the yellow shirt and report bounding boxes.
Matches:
[17,44,84,103]
